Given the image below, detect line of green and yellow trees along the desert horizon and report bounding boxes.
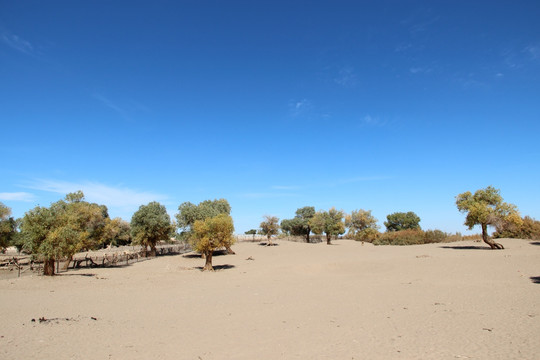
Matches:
[0,186,540,275]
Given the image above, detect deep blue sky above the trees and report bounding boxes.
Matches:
[0,0,540,233]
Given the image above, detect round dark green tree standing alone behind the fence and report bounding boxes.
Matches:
[131,201,174,256]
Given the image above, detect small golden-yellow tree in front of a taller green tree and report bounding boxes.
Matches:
[189,213,234,271]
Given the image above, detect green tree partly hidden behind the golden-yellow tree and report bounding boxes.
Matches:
[176,199,234,254]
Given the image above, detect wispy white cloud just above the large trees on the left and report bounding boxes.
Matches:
[26,179,168,211]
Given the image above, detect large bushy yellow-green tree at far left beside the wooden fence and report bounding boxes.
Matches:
[20,191,108,275]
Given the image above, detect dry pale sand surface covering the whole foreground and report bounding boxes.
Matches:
[0,239,540,360]
